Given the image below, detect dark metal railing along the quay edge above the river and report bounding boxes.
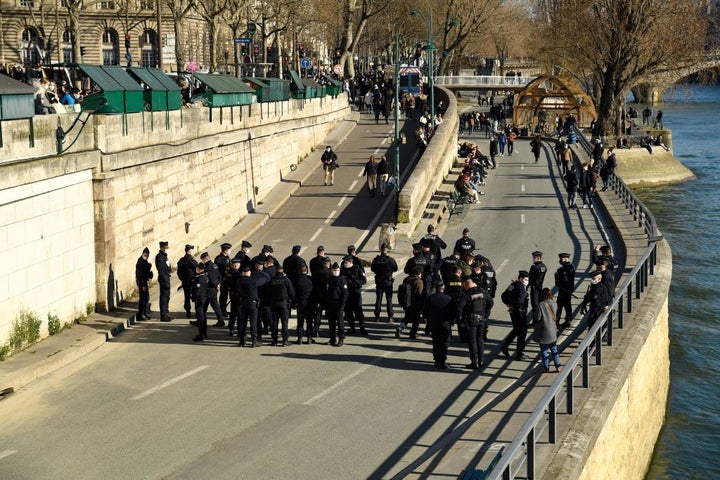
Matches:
[478,125,662,480]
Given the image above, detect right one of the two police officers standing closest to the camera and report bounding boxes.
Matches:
[456,277,493,370]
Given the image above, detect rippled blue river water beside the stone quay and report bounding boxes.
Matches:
[636,85,720,480]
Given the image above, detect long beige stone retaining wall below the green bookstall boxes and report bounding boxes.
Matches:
[0,95,350,344]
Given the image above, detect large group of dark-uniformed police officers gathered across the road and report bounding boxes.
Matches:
[136,231,616,370]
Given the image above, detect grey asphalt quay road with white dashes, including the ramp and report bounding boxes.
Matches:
[0,122,620,479]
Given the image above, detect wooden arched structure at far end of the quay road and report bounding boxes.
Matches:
[513,75,597,131]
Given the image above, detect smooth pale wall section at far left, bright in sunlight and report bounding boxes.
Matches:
[0,169,95,343]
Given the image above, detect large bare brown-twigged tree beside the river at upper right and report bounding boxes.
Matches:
[538,0,707,135]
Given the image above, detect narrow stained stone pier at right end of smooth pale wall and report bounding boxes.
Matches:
[93,172,121,312]
